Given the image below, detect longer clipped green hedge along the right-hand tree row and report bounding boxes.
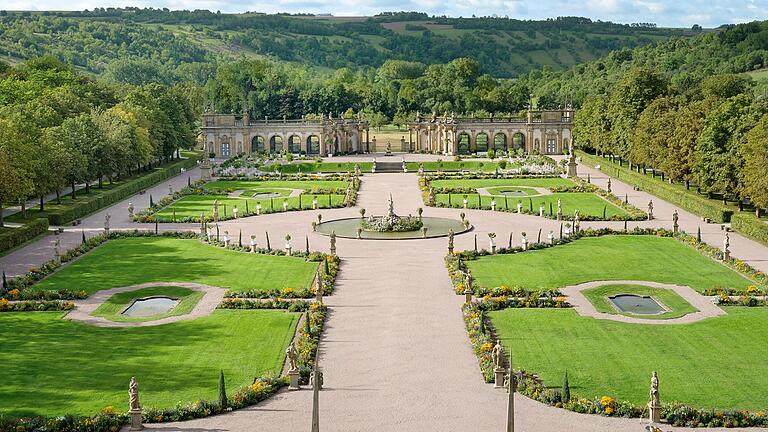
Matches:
[576,151,733,223]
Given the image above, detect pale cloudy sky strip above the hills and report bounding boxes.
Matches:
[0,0,768,27]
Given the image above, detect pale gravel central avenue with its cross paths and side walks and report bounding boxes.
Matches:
[0,155,768,432]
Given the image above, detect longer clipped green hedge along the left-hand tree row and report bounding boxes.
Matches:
[48,157,197,225]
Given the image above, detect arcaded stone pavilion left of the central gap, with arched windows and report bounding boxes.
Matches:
[202,112,368,159]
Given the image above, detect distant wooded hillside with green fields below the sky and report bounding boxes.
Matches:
[0,8,688,80]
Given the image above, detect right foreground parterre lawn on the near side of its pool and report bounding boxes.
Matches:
[489,307,768,410]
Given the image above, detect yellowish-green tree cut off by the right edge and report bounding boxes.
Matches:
[741,114,768,216]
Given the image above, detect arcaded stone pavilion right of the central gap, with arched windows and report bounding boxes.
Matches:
[409,107,574,155]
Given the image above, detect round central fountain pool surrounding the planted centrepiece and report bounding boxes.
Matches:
[317,217,472,240]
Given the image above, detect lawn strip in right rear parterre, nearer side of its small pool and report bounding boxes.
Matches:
[435,192,629,219]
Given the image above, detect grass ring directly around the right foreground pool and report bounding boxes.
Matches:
[582,284,698,319]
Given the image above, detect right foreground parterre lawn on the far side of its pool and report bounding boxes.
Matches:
[467,233,752,291]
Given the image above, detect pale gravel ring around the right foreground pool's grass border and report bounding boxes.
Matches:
[560,280,725,325]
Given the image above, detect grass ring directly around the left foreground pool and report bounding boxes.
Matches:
[91,286,205,322]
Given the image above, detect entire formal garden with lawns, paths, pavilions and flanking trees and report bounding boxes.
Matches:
[0,11,768,432]
